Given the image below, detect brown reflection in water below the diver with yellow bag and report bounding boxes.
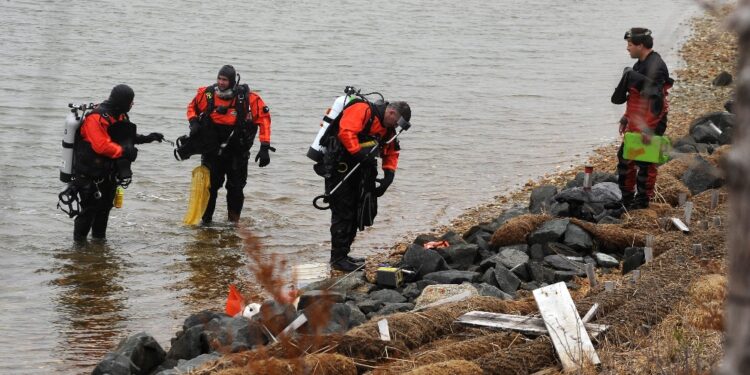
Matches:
[177,227,245,310]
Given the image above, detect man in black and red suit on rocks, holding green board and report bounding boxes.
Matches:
[612,27,674,209]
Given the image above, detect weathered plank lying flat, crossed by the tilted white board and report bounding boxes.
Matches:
[456,311,609,337]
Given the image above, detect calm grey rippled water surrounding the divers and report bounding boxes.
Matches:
[0,0,697,374]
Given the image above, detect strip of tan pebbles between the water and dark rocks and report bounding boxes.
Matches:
[89,3,732,375]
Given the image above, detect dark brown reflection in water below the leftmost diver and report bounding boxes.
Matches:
[50,241,128,370]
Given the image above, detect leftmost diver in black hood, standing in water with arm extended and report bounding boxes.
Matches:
[70,84,164,241]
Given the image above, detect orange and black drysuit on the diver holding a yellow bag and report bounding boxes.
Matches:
[187,85,271,223]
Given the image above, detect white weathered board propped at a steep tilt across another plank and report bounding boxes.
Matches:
[533,282,601,371]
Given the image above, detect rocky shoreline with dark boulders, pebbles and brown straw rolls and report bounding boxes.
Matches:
[94,4,736,375]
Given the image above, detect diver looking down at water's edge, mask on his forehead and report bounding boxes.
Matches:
[318,100,411,272]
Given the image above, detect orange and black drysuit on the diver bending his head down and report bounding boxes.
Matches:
[325,102,399,262]
